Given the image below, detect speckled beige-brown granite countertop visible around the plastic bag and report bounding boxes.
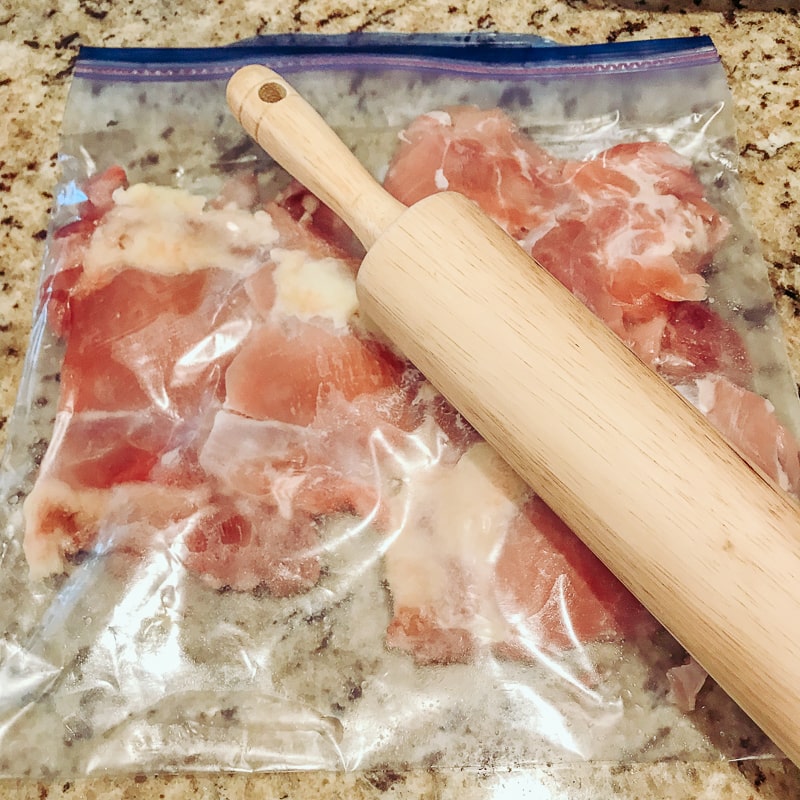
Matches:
[0,0,800,800]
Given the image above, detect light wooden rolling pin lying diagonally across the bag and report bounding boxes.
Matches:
[227,65,800,764]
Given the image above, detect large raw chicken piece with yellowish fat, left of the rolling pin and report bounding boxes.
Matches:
[24,168,412,595]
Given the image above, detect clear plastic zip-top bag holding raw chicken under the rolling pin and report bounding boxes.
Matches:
[0,35,800,775]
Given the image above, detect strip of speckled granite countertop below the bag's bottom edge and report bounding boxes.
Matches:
[0,762,800,800]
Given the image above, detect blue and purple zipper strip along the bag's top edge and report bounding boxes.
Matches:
[75,32,719,81]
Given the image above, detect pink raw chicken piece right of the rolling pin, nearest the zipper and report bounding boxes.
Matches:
[385,107,729,364]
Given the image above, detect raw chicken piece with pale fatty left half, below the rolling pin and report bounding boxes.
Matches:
[386,442,653,664]
